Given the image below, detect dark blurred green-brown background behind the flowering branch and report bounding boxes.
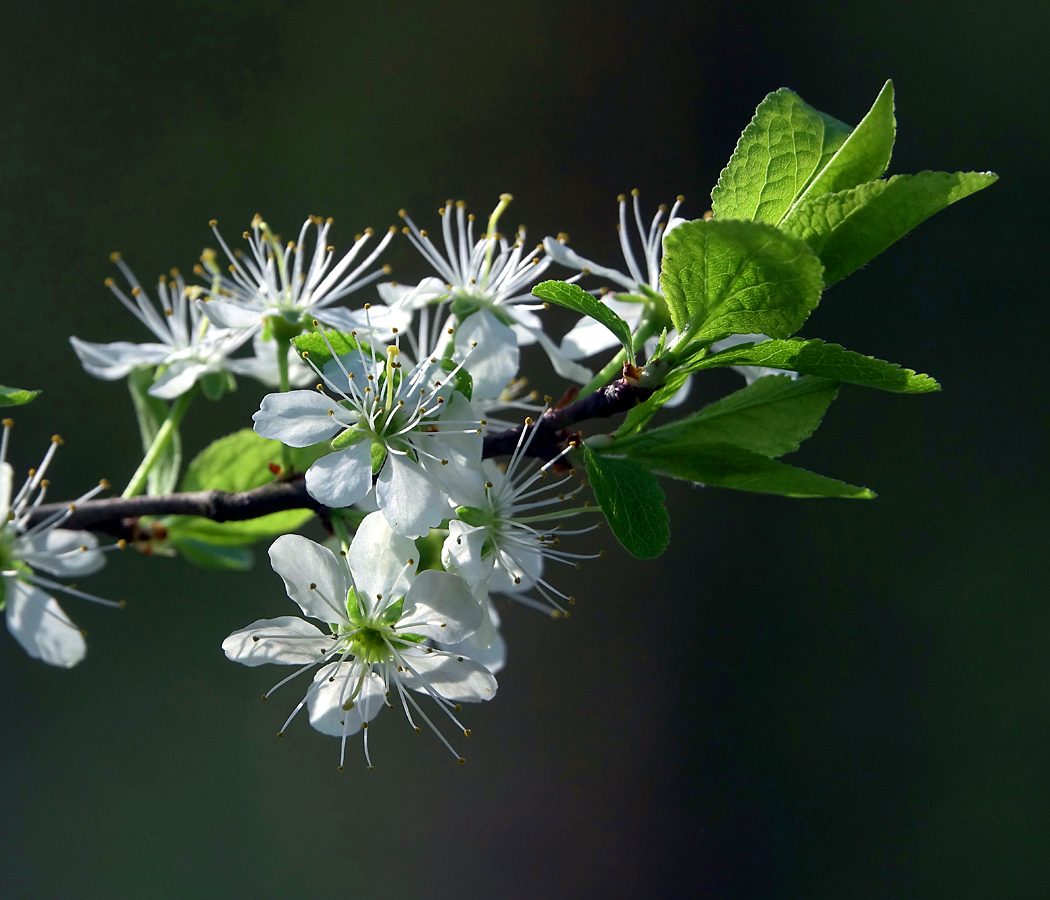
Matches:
[0,0,1050,900]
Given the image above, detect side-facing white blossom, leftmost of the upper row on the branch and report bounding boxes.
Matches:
[69,253,251,392]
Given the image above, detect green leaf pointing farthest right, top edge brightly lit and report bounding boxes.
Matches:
[785,172,999,285]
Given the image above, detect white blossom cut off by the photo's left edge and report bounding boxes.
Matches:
[0,419,121,668]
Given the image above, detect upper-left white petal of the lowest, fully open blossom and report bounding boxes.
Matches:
[270,535,350,623]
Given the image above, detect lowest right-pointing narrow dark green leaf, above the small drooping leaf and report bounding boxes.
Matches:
[602,443,875,500]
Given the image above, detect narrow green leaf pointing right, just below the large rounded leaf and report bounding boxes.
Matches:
[690,337,941,394]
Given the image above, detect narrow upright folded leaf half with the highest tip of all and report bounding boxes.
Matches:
[784,81,897,214]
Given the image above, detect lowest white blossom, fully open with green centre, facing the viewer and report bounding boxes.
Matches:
[223,512,497,769]
